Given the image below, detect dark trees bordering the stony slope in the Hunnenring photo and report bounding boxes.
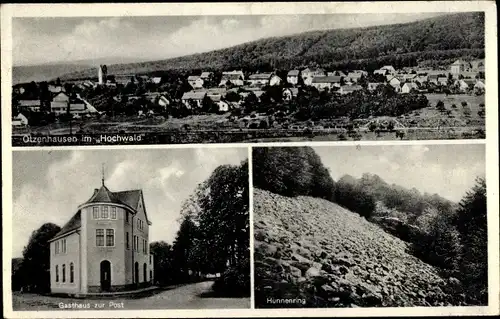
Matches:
[252,147,488,304]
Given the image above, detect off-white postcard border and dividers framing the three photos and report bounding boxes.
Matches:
[1,1,500,318]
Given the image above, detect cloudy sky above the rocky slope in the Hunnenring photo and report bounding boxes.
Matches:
[314,144,486,202]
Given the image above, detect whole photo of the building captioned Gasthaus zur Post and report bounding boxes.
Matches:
[11,148,254,311]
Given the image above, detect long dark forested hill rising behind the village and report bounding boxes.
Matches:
[62,12,485,79]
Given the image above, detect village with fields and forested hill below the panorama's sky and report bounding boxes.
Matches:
[12,13,485,146]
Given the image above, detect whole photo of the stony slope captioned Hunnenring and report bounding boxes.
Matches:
[252,144,488,308]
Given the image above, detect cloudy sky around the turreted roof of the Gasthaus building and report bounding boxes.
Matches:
[12,147,248,257]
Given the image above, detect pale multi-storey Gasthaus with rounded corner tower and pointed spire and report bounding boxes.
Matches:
[49,179,154,295]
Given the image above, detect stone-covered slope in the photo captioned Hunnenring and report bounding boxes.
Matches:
[254,189,464,307]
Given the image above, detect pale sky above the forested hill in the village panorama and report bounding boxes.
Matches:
[12,13,444,65]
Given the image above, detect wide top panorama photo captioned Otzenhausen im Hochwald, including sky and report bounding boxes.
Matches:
[12,12,485,146]
